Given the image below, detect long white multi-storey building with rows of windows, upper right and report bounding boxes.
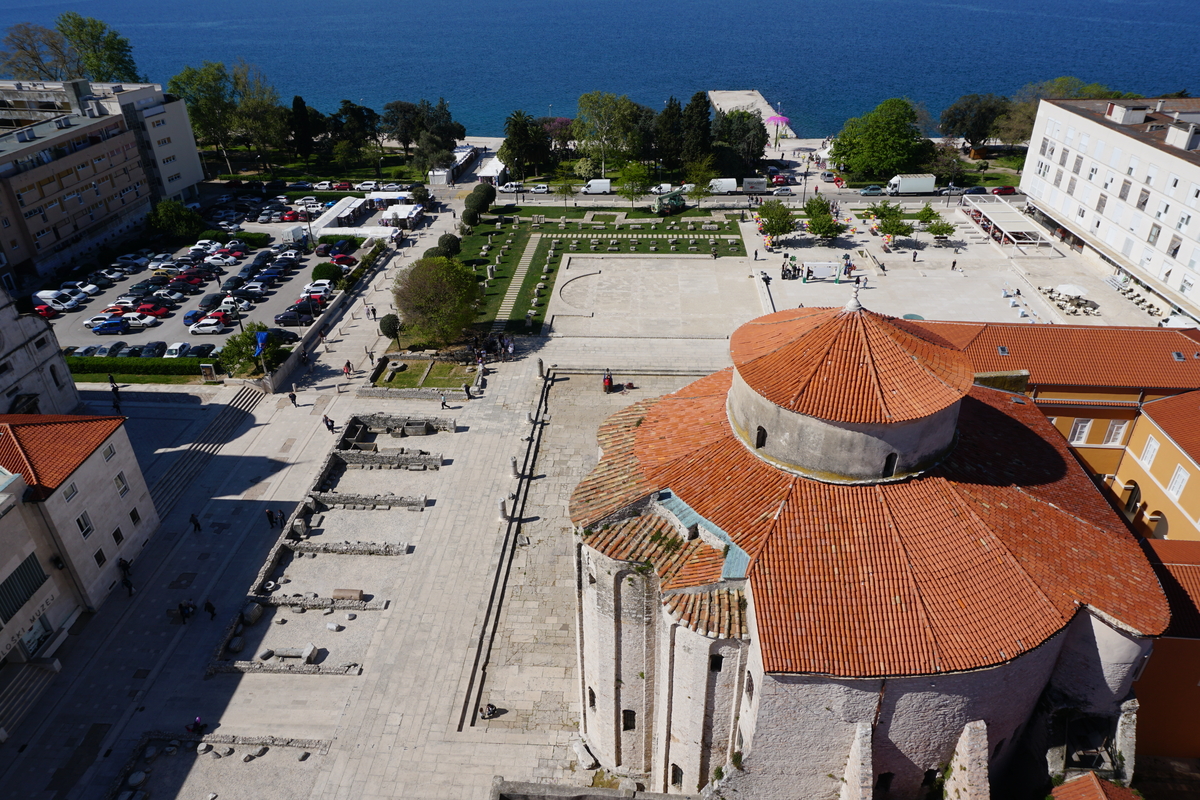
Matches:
[1021,98,1200,326]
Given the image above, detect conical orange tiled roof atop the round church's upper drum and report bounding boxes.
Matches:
[730,308,974,423]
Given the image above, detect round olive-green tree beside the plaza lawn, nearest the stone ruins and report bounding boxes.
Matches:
[392,258,479,344]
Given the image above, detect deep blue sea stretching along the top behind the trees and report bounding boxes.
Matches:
[0,0,1200,137]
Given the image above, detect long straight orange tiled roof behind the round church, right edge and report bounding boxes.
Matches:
[894,319,1200,389]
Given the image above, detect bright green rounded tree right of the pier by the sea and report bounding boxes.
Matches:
[829,97,932,178]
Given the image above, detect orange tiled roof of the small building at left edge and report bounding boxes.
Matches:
[0,414,125,500]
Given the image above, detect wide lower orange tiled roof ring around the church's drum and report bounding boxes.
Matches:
[572,369,1169,676]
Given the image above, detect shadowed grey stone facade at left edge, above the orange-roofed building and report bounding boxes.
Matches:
[0,289,80,414]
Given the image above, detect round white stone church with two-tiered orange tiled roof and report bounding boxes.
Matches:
[570,301,1170,800]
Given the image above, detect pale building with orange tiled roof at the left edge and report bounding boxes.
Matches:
[0,414,158,676]
